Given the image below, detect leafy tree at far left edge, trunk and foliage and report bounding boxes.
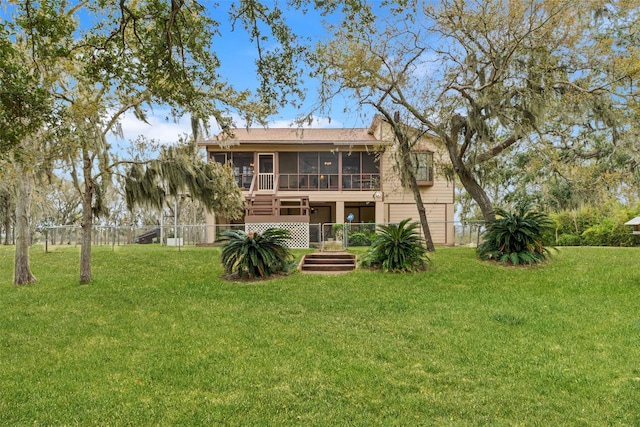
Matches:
[0,10,64,285]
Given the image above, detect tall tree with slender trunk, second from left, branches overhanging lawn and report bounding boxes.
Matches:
[3,0,302,283]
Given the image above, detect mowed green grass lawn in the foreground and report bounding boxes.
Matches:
[0,246,640,426]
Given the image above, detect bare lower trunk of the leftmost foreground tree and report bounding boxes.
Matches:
[13,166,36,285]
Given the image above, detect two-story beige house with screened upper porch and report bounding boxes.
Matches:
[200,117,454,245]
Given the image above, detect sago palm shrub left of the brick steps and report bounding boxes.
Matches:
[221,228,293,278]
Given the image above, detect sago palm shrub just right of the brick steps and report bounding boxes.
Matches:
[362,219,429,272]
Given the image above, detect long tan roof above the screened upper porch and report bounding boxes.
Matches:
[199,128,379,145]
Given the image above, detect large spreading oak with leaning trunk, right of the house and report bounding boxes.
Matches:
[317,0,639,220]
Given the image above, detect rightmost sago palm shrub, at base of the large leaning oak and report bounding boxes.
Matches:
[477,207,553,265]
